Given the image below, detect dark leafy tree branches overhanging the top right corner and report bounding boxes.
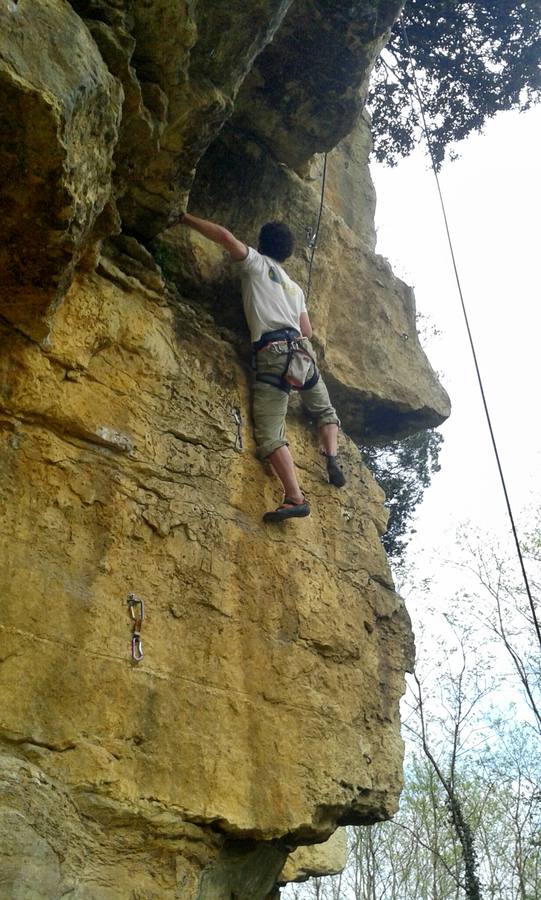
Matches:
[369,0,541,165]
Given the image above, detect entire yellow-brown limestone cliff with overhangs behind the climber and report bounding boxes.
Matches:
[0,0,449,900]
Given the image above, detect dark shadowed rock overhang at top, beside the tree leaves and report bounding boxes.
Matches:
[233,0,403,169]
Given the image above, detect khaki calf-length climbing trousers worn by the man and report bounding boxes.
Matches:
[253,341,340,459]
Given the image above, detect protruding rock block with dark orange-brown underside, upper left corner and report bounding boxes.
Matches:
[0,0,122,337]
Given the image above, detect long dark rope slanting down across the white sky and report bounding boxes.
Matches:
[400,16,541,646]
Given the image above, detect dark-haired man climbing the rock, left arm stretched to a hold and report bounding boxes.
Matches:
[181,213,346,522]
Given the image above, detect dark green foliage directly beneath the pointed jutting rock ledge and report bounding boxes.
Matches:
[362,429,443,565]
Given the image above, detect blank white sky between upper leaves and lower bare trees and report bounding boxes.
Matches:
[372,107,541,577]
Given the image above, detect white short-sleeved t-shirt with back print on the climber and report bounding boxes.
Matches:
[237,247,306,342]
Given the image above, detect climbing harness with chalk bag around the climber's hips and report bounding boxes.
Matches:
[252,328,319,394]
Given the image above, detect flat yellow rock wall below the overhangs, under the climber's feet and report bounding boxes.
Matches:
[0,264,411,896]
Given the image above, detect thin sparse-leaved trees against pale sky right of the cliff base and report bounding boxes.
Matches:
[283,522,541,900]
